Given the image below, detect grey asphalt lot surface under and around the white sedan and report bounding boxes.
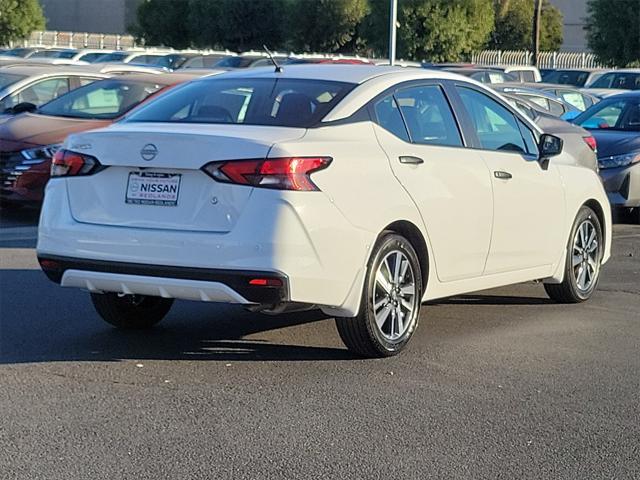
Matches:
[0,211,640,480]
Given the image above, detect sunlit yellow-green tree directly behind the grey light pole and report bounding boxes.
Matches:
[362,0,494,62]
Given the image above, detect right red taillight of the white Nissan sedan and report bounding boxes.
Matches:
[202,157,331,191]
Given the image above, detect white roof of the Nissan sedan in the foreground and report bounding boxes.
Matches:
[204,64,461,84]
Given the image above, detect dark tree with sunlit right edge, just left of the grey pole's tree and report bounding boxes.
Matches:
[289,0,369,52]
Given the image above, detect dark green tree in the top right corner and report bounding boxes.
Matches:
[586,0,640,67]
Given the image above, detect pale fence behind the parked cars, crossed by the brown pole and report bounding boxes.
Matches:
[471,50,605,68]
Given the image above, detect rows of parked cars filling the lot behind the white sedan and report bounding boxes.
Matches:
[0,48,640,220]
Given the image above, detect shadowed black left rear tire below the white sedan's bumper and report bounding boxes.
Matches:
[91,293,173,330]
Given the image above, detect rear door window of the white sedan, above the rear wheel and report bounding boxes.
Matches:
[396,85,462,147]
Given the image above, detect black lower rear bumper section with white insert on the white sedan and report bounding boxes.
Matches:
[38,255,289,305]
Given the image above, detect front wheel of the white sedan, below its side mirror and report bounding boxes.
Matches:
[544,207,603,303]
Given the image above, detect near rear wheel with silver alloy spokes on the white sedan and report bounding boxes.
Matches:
[336,232,423,357]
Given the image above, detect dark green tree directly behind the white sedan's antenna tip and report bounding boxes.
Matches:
[189,0,288,51]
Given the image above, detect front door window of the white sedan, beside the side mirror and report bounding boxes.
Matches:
[456,87,527,153]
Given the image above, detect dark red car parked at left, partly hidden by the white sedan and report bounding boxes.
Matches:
[0,74,202,206]
